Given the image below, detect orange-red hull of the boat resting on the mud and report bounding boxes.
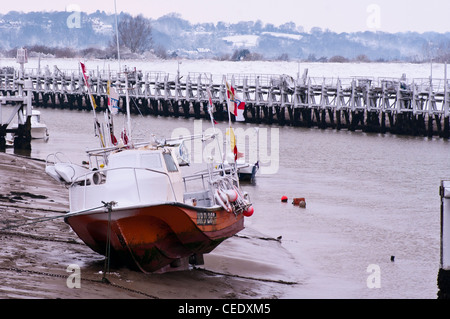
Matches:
[65,203,244,272]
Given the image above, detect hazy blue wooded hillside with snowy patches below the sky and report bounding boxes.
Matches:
[0,12,450,63]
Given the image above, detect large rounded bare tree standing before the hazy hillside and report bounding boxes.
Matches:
[114,14,153,53]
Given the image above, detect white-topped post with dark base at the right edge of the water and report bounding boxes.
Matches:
[438,181,450,299]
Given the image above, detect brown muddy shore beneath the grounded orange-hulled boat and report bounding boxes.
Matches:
[0,153,299,299]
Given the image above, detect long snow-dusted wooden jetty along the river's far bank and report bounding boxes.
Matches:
[0,67,450,139]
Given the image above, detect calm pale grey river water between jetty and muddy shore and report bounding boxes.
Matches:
[3,58,450,299]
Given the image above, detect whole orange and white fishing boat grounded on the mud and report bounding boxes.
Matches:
[46,63,253,273]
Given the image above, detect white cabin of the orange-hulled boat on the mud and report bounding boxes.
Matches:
[70,148,183,212]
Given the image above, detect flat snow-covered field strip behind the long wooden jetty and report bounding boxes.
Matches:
[0,58,445,80]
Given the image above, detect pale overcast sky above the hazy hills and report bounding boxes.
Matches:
[0,0,450,32]
